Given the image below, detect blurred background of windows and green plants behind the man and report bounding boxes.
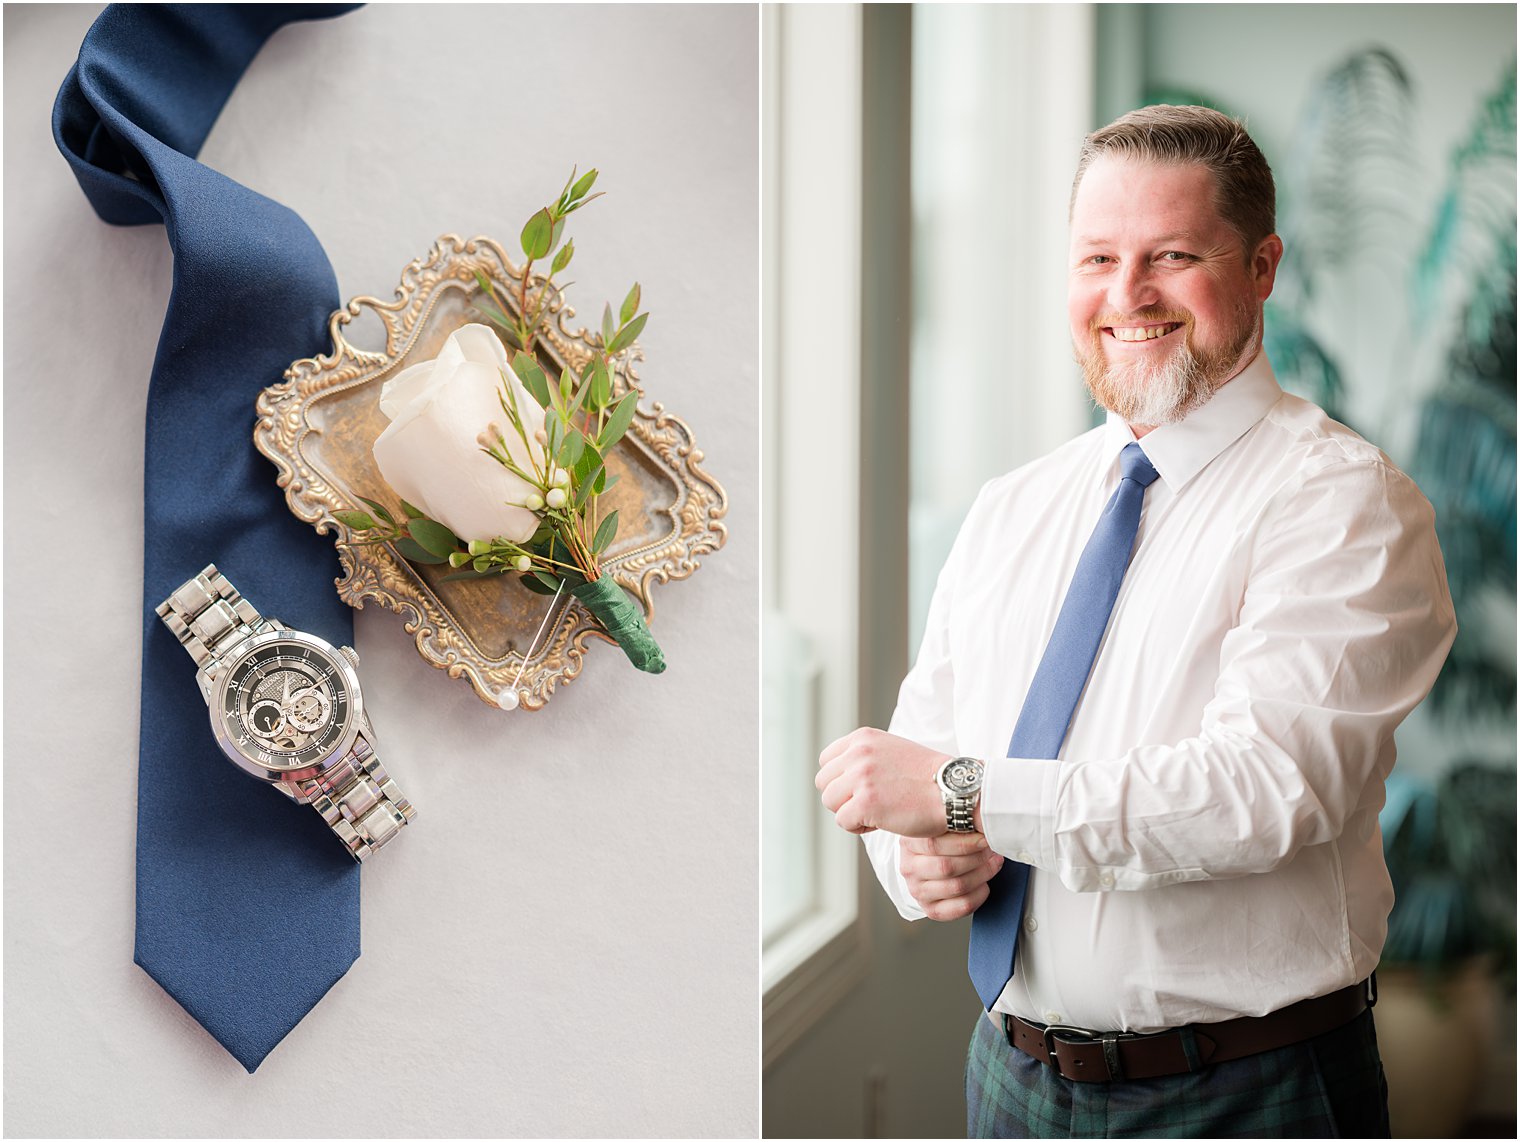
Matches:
[762,5,1515,1137]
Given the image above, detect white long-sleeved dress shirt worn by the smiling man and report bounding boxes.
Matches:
[866,354,1456,1031]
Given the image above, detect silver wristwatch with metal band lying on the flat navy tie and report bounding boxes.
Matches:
[157,564,416,861]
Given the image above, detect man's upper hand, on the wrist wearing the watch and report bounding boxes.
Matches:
[813,728,950,836]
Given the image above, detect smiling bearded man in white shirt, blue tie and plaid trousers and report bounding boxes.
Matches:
[818,106,1455,1137]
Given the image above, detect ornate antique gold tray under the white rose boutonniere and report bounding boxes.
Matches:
[254,234,728,710]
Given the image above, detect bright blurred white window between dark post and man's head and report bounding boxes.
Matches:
[909,5,1093,652]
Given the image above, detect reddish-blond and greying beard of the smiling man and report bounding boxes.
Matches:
[1075,303,1260,426]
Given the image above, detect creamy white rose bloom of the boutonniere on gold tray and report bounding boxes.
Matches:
[374,324,544,543]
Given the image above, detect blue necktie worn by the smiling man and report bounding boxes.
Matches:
[967,444,1155,1011]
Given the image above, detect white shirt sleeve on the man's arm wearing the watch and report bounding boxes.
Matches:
[978,461,1456,893]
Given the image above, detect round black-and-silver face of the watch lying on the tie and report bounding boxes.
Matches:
[213,631,359,772]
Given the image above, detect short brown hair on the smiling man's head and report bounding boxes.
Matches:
[1072,103,1277,254]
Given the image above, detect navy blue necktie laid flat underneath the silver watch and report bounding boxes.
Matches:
[53,5,359,1072]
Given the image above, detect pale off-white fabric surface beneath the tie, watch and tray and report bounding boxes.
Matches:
[3,5,758,1137]
